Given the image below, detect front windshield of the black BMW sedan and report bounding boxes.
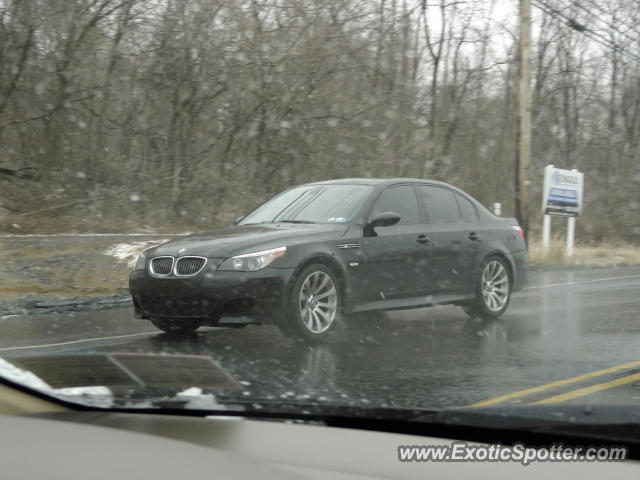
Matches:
[240,185,373,225]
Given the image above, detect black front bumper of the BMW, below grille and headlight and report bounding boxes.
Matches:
[129,265,294,325]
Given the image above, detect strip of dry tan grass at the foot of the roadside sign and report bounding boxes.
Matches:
[529,239,640,268]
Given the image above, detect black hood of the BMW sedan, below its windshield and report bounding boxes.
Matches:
[145,223,348,257]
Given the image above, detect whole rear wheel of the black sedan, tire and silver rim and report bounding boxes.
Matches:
[462,256,511,318]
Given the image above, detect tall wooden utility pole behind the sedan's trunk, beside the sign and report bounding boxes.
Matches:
[515,0,531,239]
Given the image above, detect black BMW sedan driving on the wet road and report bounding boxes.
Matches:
[130,178,528,343]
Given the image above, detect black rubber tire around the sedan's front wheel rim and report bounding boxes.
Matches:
[277,263,342,345]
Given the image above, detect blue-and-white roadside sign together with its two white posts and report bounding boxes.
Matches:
[542,165,584,257]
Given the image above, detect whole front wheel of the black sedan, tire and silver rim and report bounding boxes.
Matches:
[278,263,341,343]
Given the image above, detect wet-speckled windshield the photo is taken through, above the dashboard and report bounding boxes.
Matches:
[0,0,640,440]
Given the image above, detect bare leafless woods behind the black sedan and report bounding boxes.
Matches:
[0,0,640,241]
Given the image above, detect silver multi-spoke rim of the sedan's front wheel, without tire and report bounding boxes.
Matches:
[298,271,338,334]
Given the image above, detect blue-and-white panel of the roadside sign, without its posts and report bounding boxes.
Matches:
[542,165,584,217]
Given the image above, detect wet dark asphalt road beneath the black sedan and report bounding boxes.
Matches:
[0,266,640,408]
